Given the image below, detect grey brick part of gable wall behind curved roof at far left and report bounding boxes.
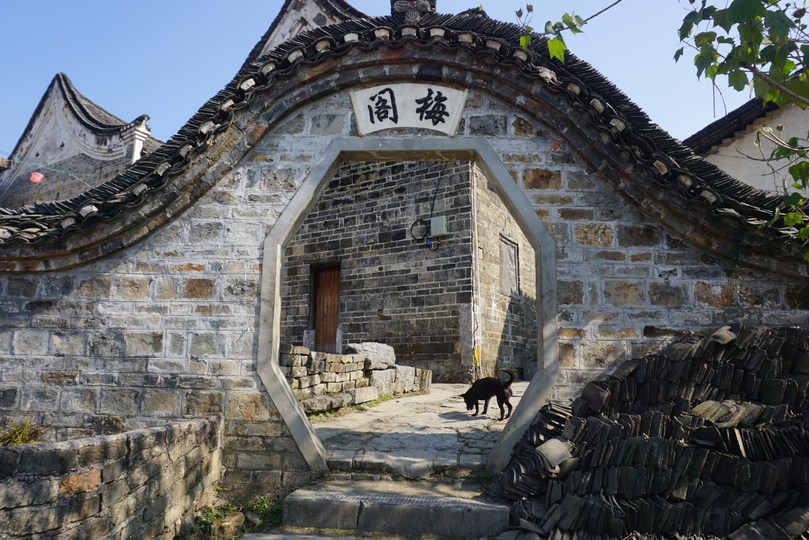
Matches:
[0,154,132,208]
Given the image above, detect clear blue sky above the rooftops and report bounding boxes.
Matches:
[0,0,749,157]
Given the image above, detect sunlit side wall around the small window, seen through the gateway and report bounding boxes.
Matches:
[473,168,537,377]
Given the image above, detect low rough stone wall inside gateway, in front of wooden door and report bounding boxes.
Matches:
[278,343,432,413]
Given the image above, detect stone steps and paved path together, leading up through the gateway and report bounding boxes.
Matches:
[244,383,527,540]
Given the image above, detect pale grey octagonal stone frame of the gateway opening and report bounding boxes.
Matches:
[256,138,559,472]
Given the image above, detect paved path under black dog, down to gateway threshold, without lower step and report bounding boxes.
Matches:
[314,382,528,478]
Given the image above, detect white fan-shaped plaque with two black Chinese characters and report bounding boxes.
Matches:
[351,83,468,137]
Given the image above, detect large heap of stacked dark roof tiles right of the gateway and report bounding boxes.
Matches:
[493,325,809,540]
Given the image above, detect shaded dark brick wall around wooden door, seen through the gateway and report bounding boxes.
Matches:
[282,158,472,381]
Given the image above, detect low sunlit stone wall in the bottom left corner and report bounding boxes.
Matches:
[0,417,222,540]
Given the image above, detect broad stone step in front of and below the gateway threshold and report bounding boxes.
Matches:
[274,481,509,537]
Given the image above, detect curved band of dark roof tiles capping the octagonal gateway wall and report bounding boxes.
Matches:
[0,12,795,274]
